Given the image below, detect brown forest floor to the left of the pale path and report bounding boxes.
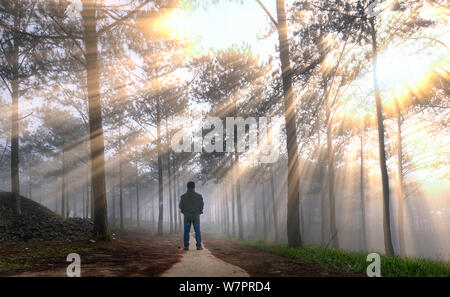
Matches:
[0,231,183,277]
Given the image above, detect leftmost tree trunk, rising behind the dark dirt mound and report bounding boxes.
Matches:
[11,44,22,215]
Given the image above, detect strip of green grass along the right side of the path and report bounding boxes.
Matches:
[227,239,450,277]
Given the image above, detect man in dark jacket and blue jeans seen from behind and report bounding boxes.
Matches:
[179,181,204,251]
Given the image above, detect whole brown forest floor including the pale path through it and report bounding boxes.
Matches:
[0,231,363,277]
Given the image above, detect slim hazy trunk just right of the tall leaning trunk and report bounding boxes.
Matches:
[395,100,406,256]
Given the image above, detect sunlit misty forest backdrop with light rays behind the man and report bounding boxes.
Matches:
[0,1,450,260]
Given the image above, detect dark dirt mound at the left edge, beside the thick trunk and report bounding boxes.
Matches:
[0,192,93,242]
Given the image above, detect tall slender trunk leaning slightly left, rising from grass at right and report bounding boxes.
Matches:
[370,17,394,255]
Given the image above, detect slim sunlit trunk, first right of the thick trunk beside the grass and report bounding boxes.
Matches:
[325,88,339,248]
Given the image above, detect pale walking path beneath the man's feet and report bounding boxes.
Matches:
[161,233,250,277]
